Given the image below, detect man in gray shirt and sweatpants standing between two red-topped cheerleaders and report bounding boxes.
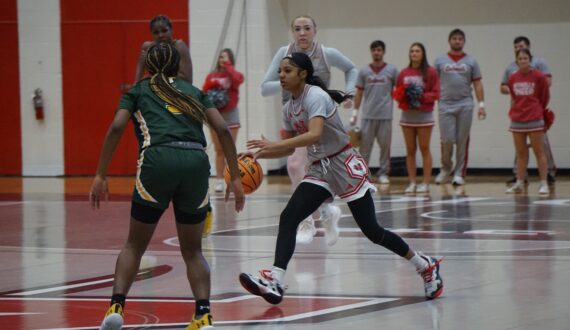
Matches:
[434,29,486,186]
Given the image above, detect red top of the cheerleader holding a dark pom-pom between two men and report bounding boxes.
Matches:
[396,66,439,112]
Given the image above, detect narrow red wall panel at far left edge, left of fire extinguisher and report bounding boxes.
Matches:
[0,0,21,175]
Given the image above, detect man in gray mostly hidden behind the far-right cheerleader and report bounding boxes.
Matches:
[501,36,556,185]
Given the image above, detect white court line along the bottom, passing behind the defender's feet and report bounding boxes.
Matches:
[37,297,394,330]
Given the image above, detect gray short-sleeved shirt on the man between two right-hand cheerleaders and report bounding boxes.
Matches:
[434,54,481,108]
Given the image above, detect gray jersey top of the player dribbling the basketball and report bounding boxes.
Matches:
[283,85,350,162]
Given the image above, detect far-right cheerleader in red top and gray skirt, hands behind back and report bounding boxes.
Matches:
[506,48,550,195]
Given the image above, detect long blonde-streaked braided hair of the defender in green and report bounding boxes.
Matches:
[145,42,206,123]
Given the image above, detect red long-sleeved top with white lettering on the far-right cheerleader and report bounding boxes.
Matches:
[508,69,550,123]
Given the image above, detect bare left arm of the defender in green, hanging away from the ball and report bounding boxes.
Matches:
[89,109,131,208]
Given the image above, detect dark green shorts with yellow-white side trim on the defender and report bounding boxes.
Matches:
[132,146,210,214]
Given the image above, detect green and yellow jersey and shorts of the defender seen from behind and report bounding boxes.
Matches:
[119,78,214,214]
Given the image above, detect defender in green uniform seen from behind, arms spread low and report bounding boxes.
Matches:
[90,43,245,330]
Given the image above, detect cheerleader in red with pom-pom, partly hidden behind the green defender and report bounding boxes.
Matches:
[202,48,243,192]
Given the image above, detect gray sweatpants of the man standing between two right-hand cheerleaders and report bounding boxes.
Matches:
[439,105,473,177]
